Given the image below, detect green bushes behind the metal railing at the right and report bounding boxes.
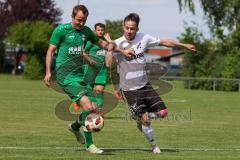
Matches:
[179,27,240,91]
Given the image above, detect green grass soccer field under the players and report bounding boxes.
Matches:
[0,75,240,160]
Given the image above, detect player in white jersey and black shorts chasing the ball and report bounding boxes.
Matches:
[107,13,195,154]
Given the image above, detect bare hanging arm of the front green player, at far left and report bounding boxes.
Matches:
[44,44,56,87]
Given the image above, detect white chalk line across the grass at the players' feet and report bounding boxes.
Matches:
[0,146,240,151]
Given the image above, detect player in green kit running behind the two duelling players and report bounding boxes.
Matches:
[68,23,111,154]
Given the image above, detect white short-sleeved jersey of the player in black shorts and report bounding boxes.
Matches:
[114,33,160,91]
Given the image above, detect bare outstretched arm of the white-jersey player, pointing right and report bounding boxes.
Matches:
[160,39,197,52]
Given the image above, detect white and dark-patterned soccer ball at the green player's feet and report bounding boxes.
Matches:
[85,113,104,132]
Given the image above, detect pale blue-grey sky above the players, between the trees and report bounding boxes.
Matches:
[55,0,209,39]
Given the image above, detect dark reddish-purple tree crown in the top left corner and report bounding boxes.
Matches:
[0,0,62,40]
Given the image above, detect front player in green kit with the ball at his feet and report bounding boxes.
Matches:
[44,5,133,153]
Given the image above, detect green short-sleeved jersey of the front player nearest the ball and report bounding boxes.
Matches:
[50,23,99,85]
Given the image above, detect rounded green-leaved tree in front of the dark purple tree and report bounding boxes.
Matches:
[5,21,54,73]
